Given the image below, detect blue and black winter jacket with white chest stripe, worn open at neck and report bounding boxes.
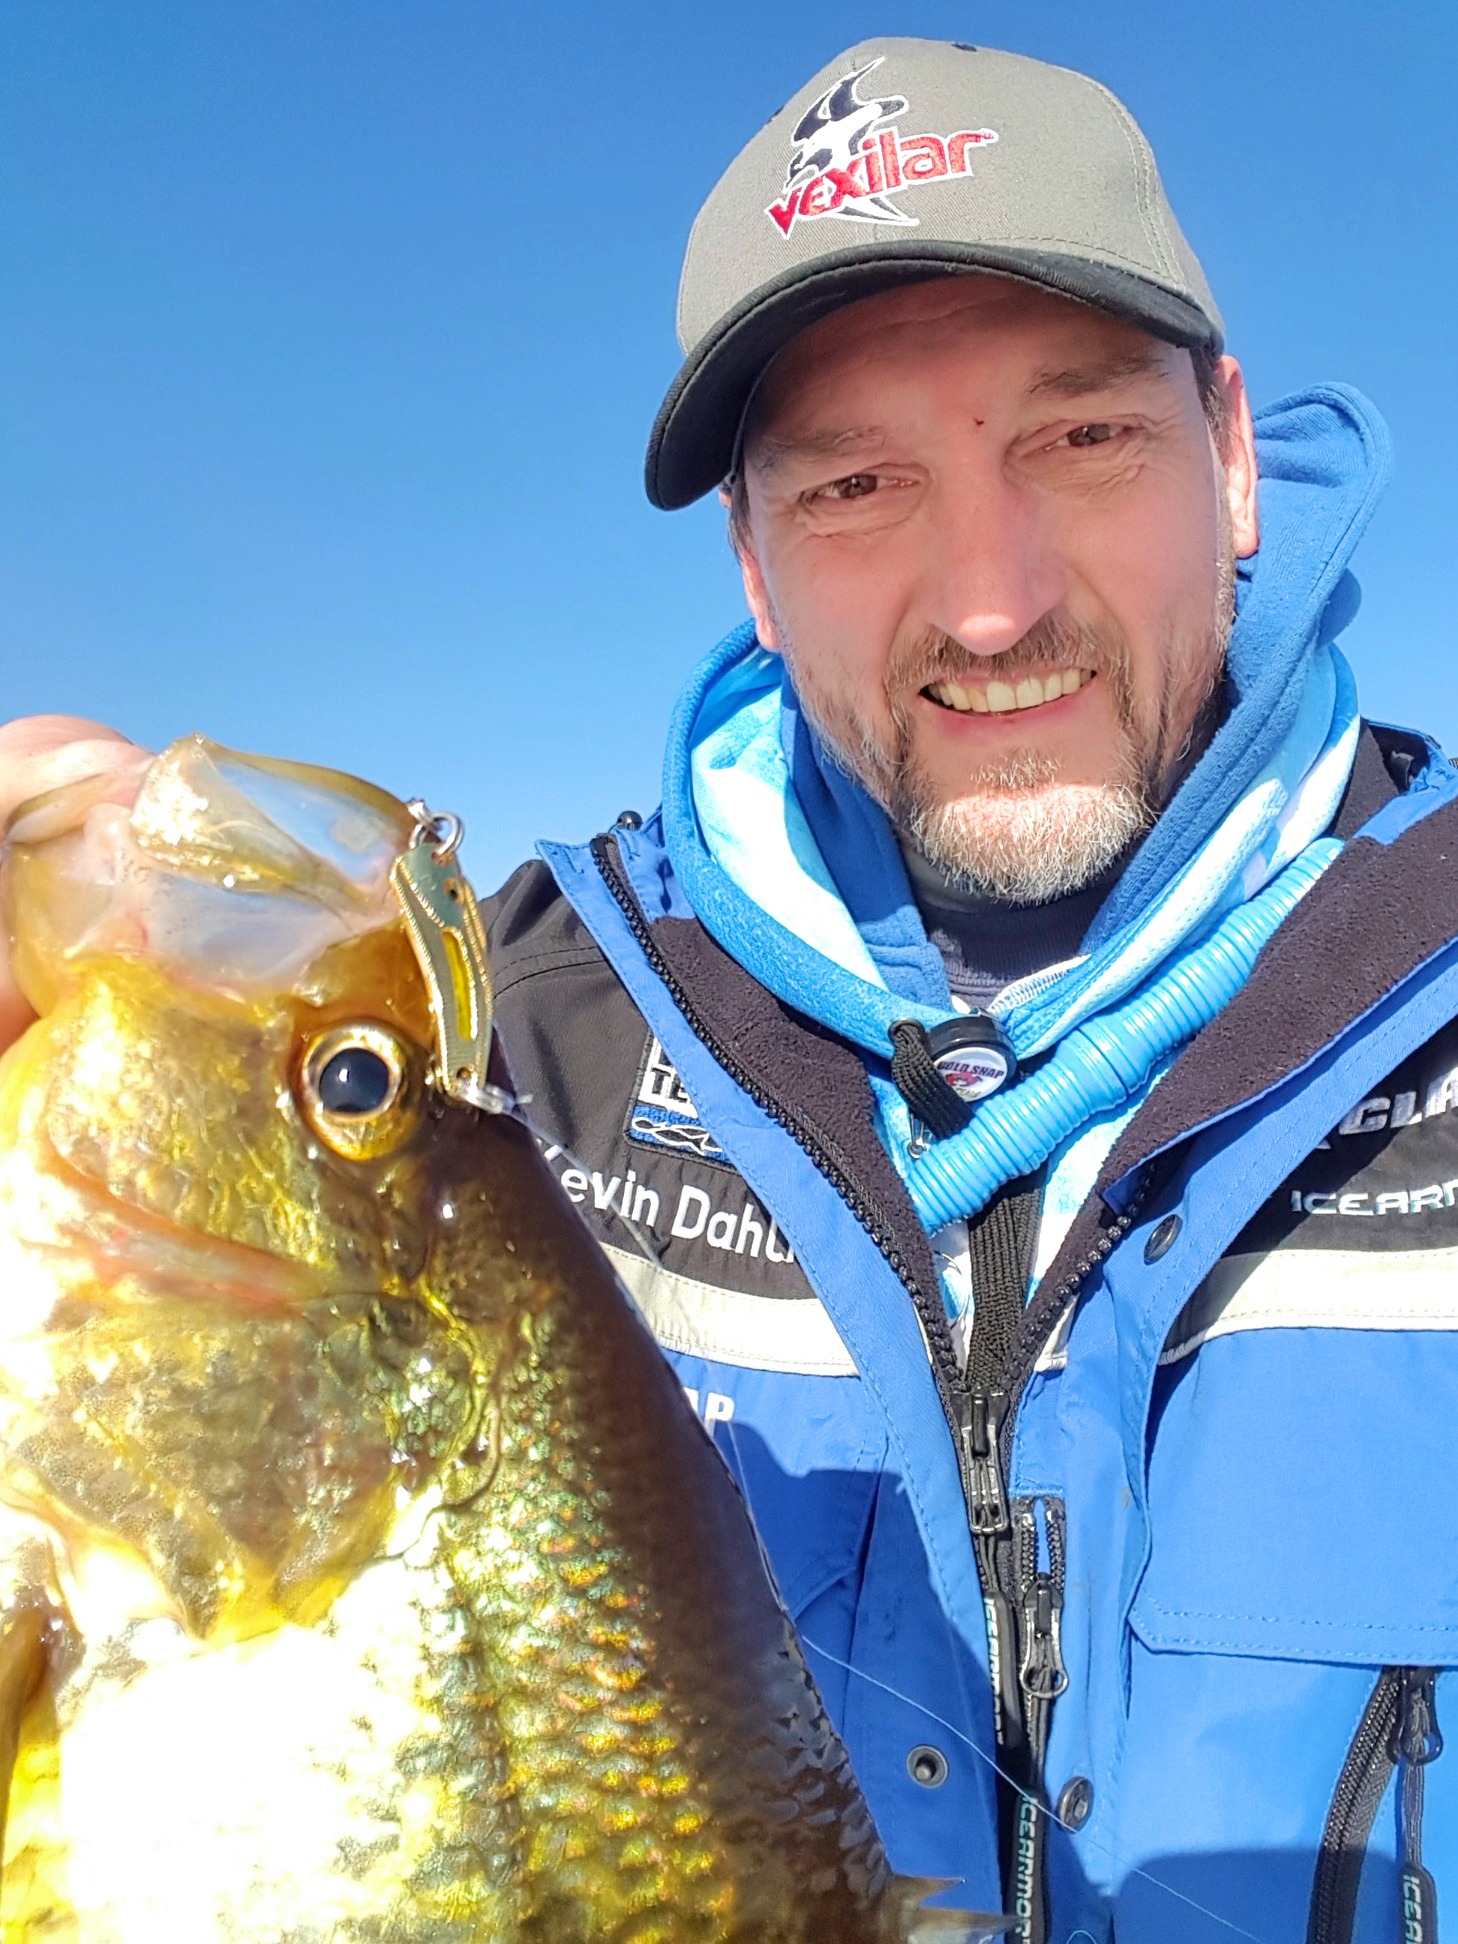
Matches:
[490,402,1458,1944]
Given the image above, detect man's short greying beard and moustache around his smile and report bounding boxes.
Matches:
[780,567,1234,904]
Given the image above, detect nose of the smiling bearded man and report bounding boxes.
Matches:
[927,469,1067,655]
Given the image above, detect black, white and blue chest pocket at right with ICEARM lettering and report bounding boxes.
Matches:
[1133,1026,1458,1666]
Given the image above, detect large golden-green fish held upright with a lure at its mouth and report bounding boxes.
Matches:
[0,737,1005,1944]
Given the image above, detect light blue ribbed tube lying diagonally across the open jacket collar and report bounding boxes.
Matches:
[908,838,1341,1234]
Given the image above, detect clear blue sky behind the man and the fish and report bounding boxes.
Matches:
[0,0,1458,886]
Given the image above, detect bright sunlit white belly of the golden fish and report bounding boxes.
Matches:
[0,1524,501,1944]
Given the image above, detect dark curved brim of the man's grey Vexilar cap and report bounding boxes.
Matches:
[643,241,1221,511]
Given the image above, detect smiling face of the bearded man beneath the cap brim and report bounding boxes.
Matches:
[741,276,1256,902]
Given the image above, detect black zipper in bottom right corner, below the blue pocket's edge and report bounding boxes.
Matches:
[1306,1668,1442,1944]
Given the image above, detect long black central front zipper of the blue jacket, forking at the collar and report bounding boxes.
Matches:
[591,836,1145,1944]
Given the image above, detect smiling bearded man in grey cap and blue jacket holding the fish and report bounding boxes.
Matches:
[6,41,1458,1944]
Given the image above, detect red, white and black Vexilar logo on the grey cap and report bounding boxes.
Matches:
[764,54,997,235]
